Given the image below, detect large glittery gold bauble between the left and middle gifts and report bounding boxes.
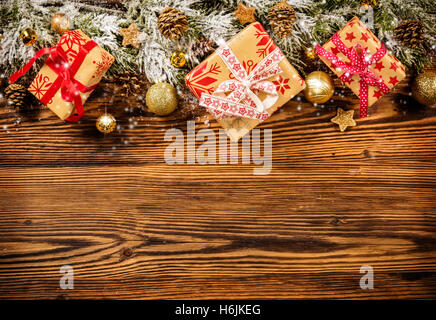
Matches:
[145,82,179,116]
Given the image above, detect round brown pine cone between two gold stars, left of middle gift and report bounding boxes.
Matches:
[157,8,188,40]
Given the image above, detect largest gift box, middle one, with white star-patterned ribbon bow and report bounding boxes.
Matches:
[185,22,305,141]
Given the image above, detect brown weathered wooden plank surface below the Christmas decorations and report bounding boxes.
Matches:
[0,70,436,299]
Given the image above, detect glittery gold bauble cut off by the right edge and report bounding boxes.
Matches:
[412,70,436,106]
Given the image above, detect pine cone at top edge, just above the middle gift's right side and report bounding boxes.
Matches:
[268,0,296,39]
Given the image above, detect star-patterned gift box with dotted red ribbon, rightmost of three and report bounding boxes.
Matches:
[316,17,406,117]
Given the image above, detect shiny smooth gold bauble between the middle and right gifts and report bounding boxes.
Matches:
[304,71,335,103]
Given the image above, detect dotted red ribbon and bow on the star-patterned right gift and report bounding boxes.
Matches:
[316,33,389,118]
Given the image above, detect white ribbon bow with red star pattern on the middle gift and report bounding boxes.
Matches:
[200,44,284,121]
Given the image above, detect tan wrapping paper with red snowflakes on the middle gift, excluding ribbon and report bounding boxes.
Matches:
[185,22,305,141]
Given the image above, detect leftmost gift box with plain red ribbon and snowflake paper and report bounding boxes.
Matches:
[10,30,114,121]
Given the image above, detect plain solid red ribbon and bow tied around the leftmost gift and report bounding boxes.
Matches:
[9,40,97,122]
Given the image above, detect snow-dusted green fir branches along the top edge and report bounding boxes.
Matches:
[0,0,436,89]
